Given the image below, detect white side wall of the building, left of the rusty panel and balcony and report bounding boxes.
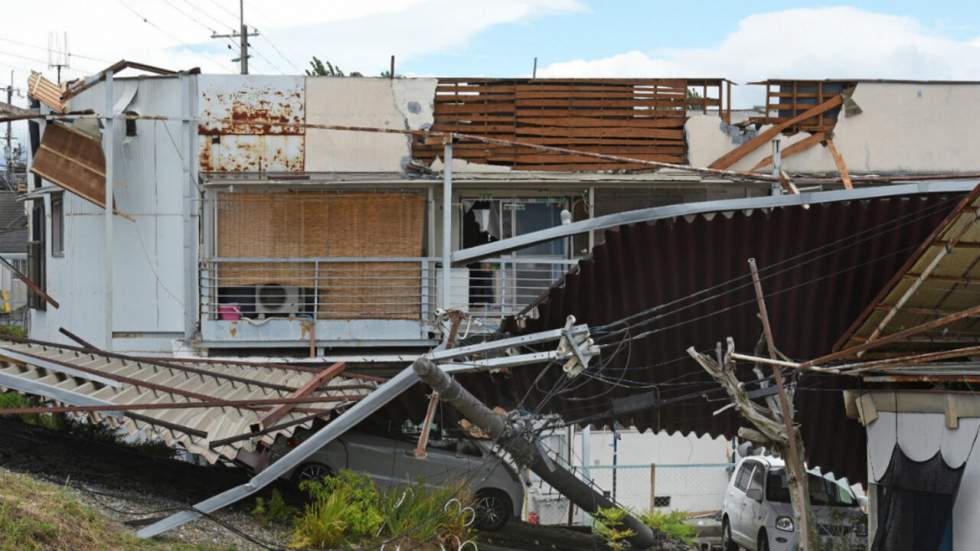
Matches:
[31,78,197,352]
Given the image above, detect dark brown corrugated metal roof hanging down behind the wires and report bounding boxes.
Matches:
[513,194,962,481]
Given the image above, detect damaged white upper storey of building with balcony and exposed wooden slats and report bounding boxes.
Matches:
[21,65,980,355]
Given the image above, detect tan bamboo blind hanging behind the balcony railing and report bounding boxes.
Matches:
[216,192,425,319]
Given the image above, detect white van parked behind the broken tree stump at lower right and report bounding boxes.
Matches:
[721,456,868,551]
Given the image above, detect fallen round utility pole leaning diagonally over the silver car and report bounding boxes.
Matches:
[412,357,657,549]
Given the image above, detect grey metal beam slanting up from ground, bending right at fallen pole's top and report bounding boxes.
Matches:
[136,325,589,538]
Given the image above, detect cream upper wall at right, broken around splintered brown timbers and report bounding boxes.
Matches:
[685,82,980,174]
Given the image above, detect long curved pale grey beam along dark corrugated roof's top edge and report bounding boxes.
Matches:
[453,180,977,264]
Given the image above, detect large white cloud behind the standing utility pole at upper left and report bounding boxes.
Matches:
[0,0,584,91]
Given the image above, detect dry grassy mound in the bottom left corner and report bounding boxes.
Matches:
[0,470,234,551]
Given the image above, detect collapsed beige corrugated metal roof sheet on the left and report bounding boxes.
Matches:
[0,341,376,463]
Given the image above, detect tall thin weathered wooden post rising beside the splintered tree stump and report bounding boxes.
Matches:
[752,258,817,550]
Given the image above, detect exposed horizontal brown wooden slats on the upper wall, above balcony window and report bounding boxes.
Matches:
[412,78,727,171]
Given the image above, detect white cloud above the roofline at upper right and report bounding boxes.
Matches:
[539,7,980,104]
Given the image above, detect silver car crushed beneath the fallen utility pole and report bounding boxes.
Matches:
[273,431,524,530]
